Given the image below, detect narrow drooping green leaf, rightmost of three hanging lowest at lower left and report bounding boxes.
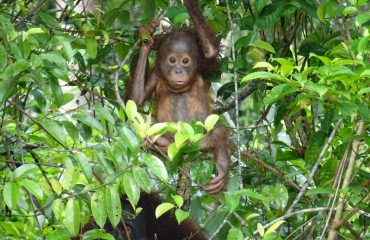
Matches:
[105,186,122,227]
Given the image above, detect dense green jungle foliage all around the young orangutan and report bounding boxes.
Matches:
[0,0,370,240]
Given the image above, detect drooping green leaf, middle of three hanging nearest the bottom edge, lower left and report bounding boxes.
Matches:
[91,190,107,228]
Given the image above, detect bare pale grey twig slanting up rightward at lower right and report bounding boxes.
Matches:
[285,119,343,215]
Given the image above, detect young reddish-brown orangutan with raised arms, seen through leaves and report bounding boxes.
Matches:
[126,0,230,194]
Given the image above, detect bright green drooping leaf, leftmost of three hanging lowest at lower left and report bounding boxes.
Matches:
[63,198,81,237]
